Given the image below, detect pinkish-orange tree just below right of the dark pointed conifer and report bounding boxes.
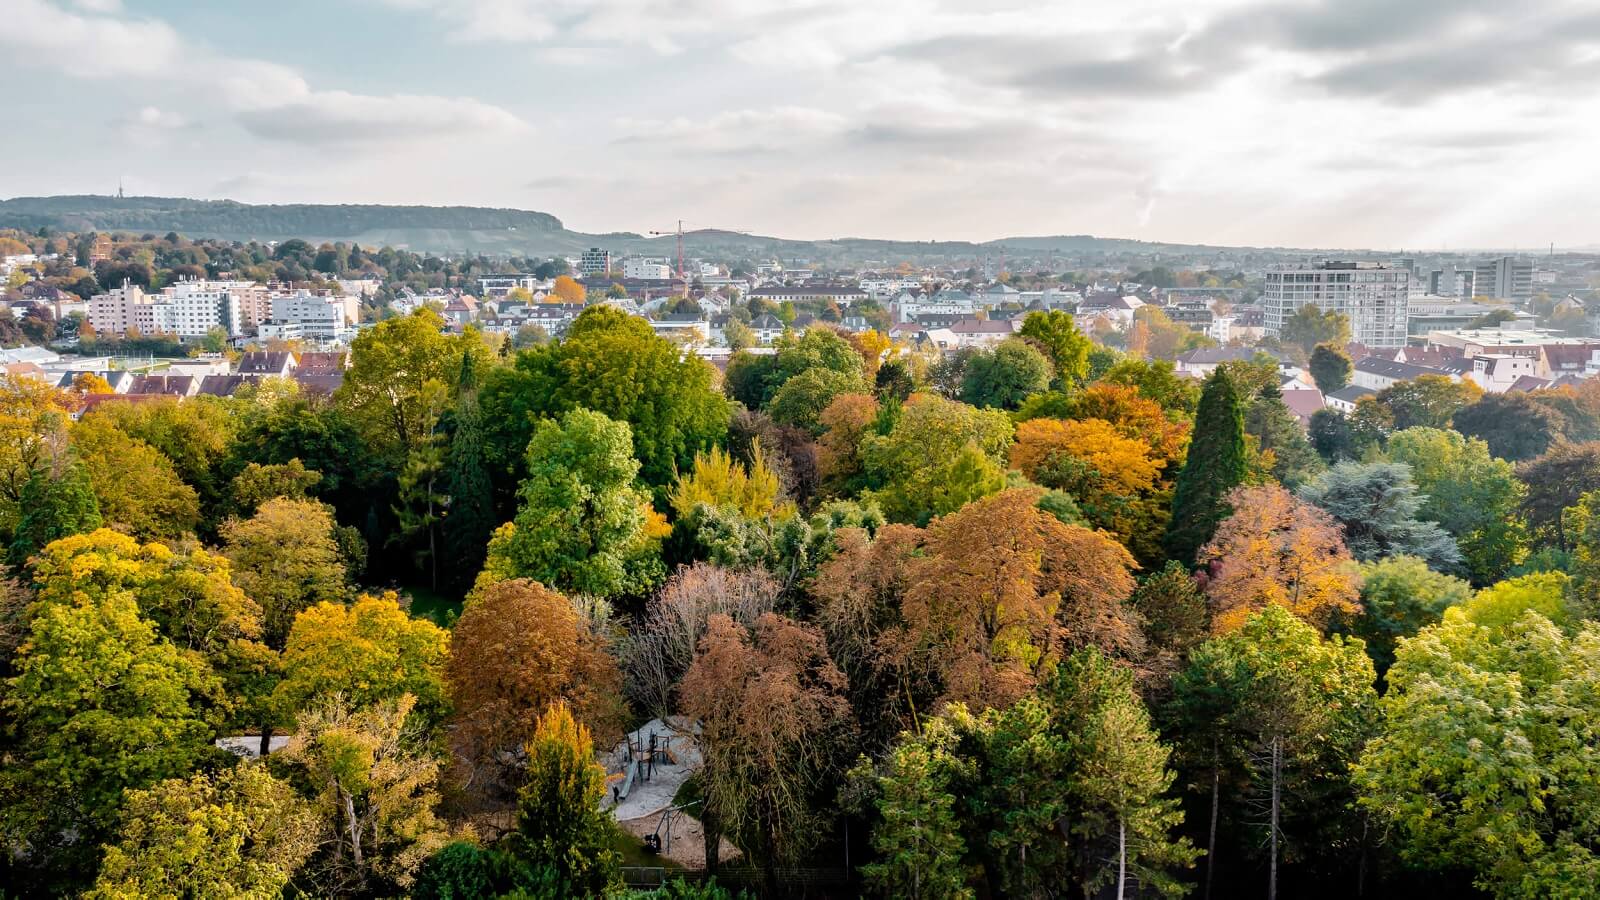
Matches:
[1200,485,1360,634]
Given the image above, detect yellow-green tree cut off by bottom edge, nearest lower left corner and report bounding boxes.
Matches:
[86,762,317,900]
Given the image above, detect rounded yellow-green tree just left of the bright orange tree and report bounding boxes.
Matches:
[861,394,1011,524]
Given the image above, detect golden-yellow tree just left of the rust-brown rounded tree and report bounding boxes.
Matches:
[274,594,450,722]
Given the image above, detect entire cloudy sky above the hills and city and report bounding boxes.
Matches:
[0,0,1600,251]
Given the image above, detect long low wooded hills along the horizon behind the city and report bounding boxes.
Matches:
[0,189,1350,257]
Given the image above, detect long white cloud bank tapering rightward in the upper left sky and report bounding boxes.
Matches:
[0,0,526,144]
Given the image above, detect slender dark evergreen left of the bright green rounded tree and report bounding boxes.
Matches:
[445,347,496,585]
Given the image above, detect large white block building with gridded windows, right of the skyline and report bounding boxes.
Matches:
[1261,261,1411,348]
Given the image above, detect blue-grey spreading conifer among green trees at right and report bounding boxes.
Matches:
[1299,463,1461,570]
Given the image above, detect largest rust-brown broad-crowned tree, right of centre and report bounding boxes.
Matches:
[891,488,1144,708]
